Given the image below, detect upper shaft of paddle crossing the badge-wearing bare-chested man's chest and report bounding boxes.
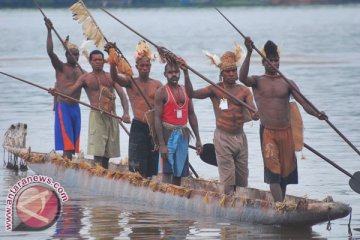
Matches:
[101,8,257,113]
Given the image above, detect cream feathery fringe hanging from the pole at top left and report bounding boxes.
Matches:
[70,0,105,48]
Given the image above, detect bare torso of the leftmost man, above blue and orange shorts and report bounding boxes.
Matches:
[55,64,82,103]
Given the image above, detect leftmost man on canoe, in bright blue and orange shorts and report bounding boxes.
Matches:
[44,18,83,160]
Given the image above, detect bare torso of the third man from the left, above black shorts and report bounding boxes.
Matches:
[126,78,162,123]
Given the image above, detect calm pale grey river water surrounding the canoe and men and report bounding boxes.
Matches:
[0,4,360,239]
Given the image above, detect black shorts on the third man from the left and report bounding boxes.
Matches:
[129,119,159,177]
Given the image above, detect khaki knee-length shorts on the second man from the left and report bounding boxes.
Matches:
[87,110,120,158]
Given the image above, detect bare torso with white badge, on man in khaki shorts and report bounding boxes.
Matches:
[210,83,254,134]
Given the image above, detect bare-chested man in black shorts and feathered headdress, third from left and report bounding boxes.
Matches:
[106,40,162,177]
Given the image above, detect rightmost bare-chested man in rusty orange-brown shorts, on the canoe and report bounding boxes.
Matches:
[240,38,327,202]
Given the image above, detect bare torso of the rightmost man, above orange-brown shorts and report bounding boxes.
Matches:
[253,75,291,129]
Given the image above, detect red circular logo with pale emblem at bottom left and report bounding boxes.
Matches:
[16,185,61,229]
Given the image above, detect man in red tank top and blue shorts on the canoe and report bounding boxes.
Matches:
[155,59,202,185]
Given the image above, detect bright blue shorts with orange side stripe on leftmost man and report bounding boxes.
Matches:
[55,101,81,153]
